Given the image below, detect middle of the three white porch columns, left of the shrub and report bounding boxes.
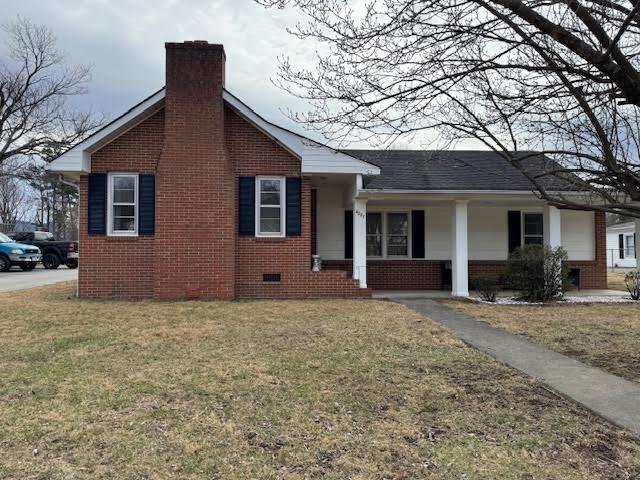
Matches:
[451,200,469,297]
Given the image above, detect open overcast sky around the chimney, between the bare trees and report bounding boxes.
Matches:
[2,0,338,139]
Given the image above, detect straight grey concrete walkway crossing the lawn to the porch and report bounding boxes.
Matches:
[396,298,640,435]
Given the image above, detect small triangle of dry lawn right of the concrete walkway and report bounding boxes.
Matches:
[447,300,640,381]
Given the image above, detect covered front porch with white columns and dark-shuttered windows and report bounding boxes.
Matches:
[312,171,606,297]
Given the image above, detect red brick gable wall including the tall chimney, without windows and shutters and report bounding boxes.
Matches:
[79,43,371,299]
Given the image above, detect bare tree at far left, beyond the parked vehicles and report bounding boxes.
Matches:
[0,17,102,171]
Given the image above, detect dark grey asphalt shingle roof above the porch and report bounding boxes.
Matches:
[344,150,578,191]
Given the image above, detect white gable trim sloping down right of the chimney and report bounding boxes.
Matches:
[223,90,380,175]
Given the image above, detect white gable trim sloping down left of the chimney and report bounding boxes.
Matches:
[46,88,165,174]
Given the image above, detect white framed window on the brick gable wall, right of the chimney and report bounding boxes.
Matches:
[256,177,286,237]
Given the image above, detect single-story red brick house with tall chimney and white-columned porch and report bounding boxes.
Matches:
[50,42,606,299]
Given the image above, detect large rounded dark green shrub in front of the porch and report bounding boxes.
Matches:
[505,245,569,302]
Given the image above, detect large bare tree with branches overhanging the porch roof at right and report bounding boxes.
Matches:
[258,0,640,218]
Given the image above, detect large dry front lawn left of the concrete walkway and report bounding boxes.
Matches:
[0,284,640,479]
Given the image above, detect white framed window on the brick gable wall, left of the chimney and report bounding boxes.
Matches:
[107,173,138,236]
